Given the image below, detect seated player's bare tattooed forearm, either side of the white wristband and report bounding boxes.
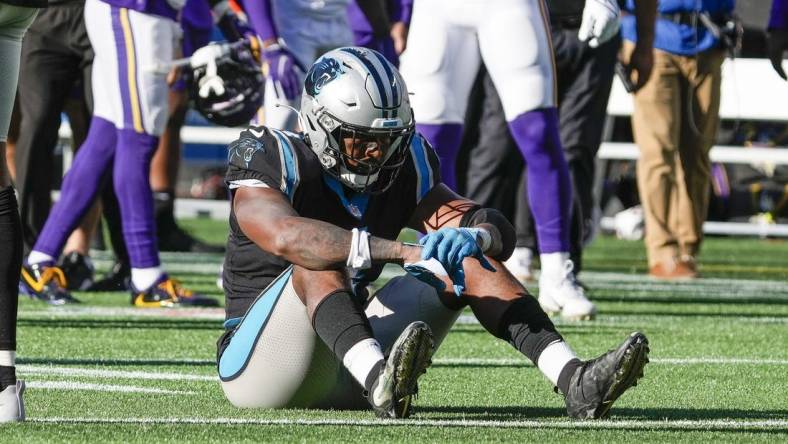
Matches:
[270,217,420,270]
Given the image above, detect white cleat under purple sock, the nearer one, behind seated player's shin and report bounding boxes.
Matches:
[539,260,596,321]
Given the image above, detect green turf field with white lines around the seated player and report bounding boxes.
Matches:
[0,220,788,443]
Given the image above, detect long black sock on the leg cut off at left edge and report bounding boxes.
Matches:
[0,187,22,360]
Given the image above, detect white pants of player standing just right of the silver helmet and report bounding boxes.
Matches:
[400,0,556,124]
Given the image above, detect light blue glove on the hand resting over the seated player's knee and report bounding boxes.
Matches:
[419,228,495,296]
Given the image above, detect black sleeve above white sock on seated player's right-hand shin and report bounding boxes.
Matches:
[496,295,563,365]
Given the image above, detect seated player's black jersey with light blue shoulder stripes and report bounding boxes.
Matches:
[222,127,440,319]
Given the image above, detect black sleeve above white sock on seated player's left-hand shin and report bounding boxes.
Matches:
[312,289,373,362]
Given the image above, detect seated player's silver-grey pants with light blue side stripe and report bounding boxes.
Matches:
[219,268,460,408]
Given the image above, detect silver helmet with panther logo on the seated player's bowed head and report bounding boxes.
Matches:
[300,46,414,194]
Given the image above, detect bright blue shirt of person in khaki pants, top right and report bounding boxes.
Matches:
[621,0,735,56]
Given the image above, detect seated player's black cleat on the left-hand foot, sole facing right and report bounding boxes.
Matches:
[367,321,435,418]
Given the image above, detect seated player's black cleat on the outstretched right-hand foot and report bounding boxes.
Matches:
[566,332,649,419]
